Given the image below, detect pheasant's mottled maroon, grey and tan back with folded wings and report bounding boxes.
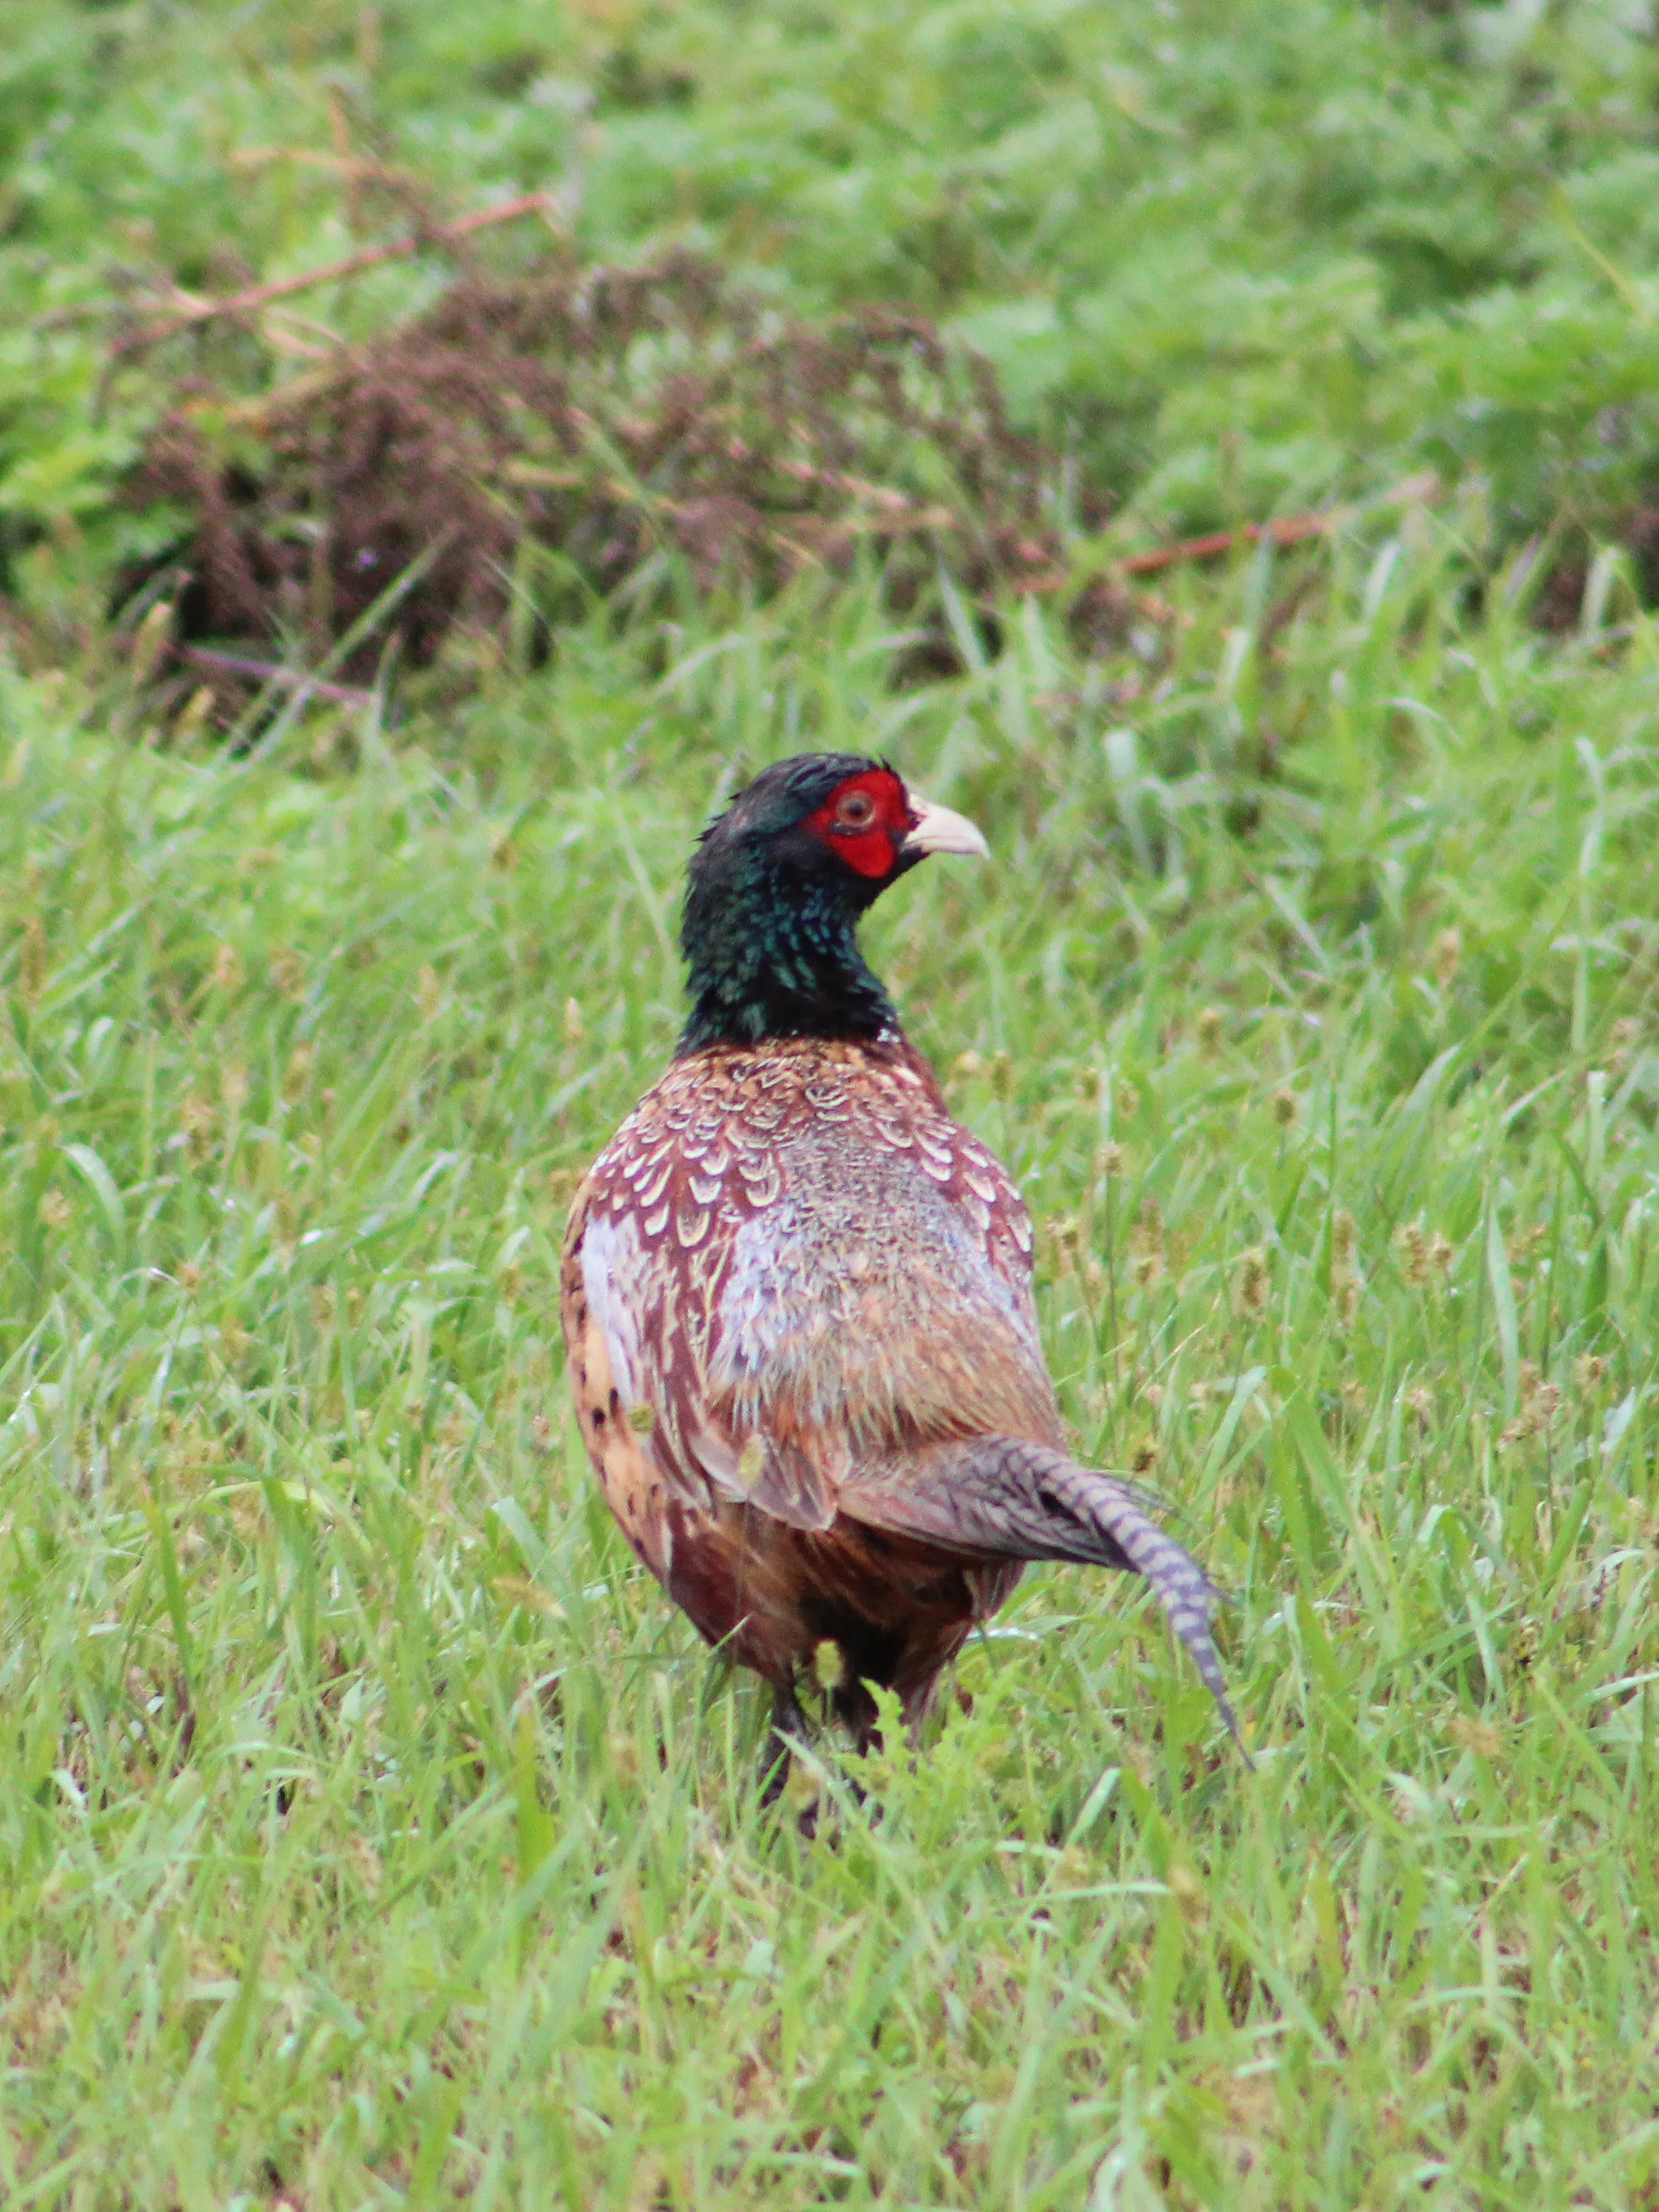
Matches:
[566,1044,1060,1528]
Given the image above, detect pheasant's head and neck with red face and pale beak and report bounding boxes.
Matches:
[679,752,986,1055]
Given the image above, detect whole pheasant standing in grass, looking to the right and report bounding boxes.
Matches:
[562,752,1237,1796]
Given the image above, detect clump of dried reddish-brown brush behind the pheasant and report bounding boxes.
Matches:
[130,254,1060,677]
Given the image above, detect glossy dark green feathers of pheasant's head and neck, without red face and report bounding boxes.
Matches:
[679,752,909,1057]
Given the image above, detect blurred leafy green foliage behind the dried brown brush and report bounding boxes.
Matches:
[0,0,1659,654]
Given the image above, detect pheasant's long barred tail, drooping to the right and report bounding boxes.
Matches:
[840,1436,1243,1749]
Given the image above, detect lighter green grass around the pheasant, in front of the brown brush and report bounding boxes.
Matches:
[0,522,1659,2212]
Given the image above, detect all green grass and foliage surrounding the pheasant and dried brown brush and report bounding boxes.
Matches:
[0,0,1659,2212]
